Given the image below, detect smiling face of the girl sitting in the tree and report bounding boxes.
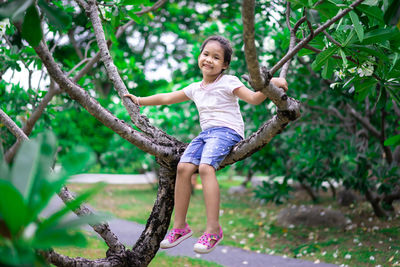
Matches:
[198,41,228,76]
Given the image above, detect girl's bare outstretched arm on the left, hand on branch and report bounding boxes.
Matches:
[124,90,189,106]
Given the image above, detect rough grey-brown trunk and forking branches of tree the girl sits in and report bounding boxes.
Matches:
[3,0,372,266]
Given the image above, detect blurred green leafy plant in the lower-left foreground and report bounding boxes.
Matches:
[0,133,103,266]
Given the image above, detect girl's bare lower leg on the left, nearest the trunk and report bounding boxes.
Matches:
[173,163,197,229]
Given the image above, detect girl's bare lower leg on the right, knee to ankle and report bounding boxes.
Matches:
[199,164,220,234]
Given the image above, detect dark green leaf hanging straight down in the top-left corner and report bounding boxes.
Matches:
[22,5,43,47]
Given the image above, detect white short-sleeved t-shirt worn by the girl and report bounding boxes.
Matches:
[182,75,244,138]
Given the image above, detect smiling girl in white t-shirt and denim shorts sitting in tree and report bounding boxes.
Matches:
[125,36,287,253]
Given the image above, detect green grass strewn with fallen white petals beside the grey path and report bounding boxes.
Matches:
[61,179,400,266]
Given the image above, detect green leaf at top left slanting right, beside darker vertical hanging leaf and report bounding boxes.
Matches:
[39,0,72,31]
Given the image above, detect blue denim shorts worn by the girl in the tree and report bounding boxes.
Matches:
[179,127,242,169]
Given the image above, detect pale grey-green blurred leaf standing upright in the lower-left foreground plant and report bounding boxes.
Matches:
[11,140,40,201]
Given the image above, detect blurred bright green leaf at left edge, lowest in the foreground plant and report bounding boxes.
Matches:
[0,180,28,236]
